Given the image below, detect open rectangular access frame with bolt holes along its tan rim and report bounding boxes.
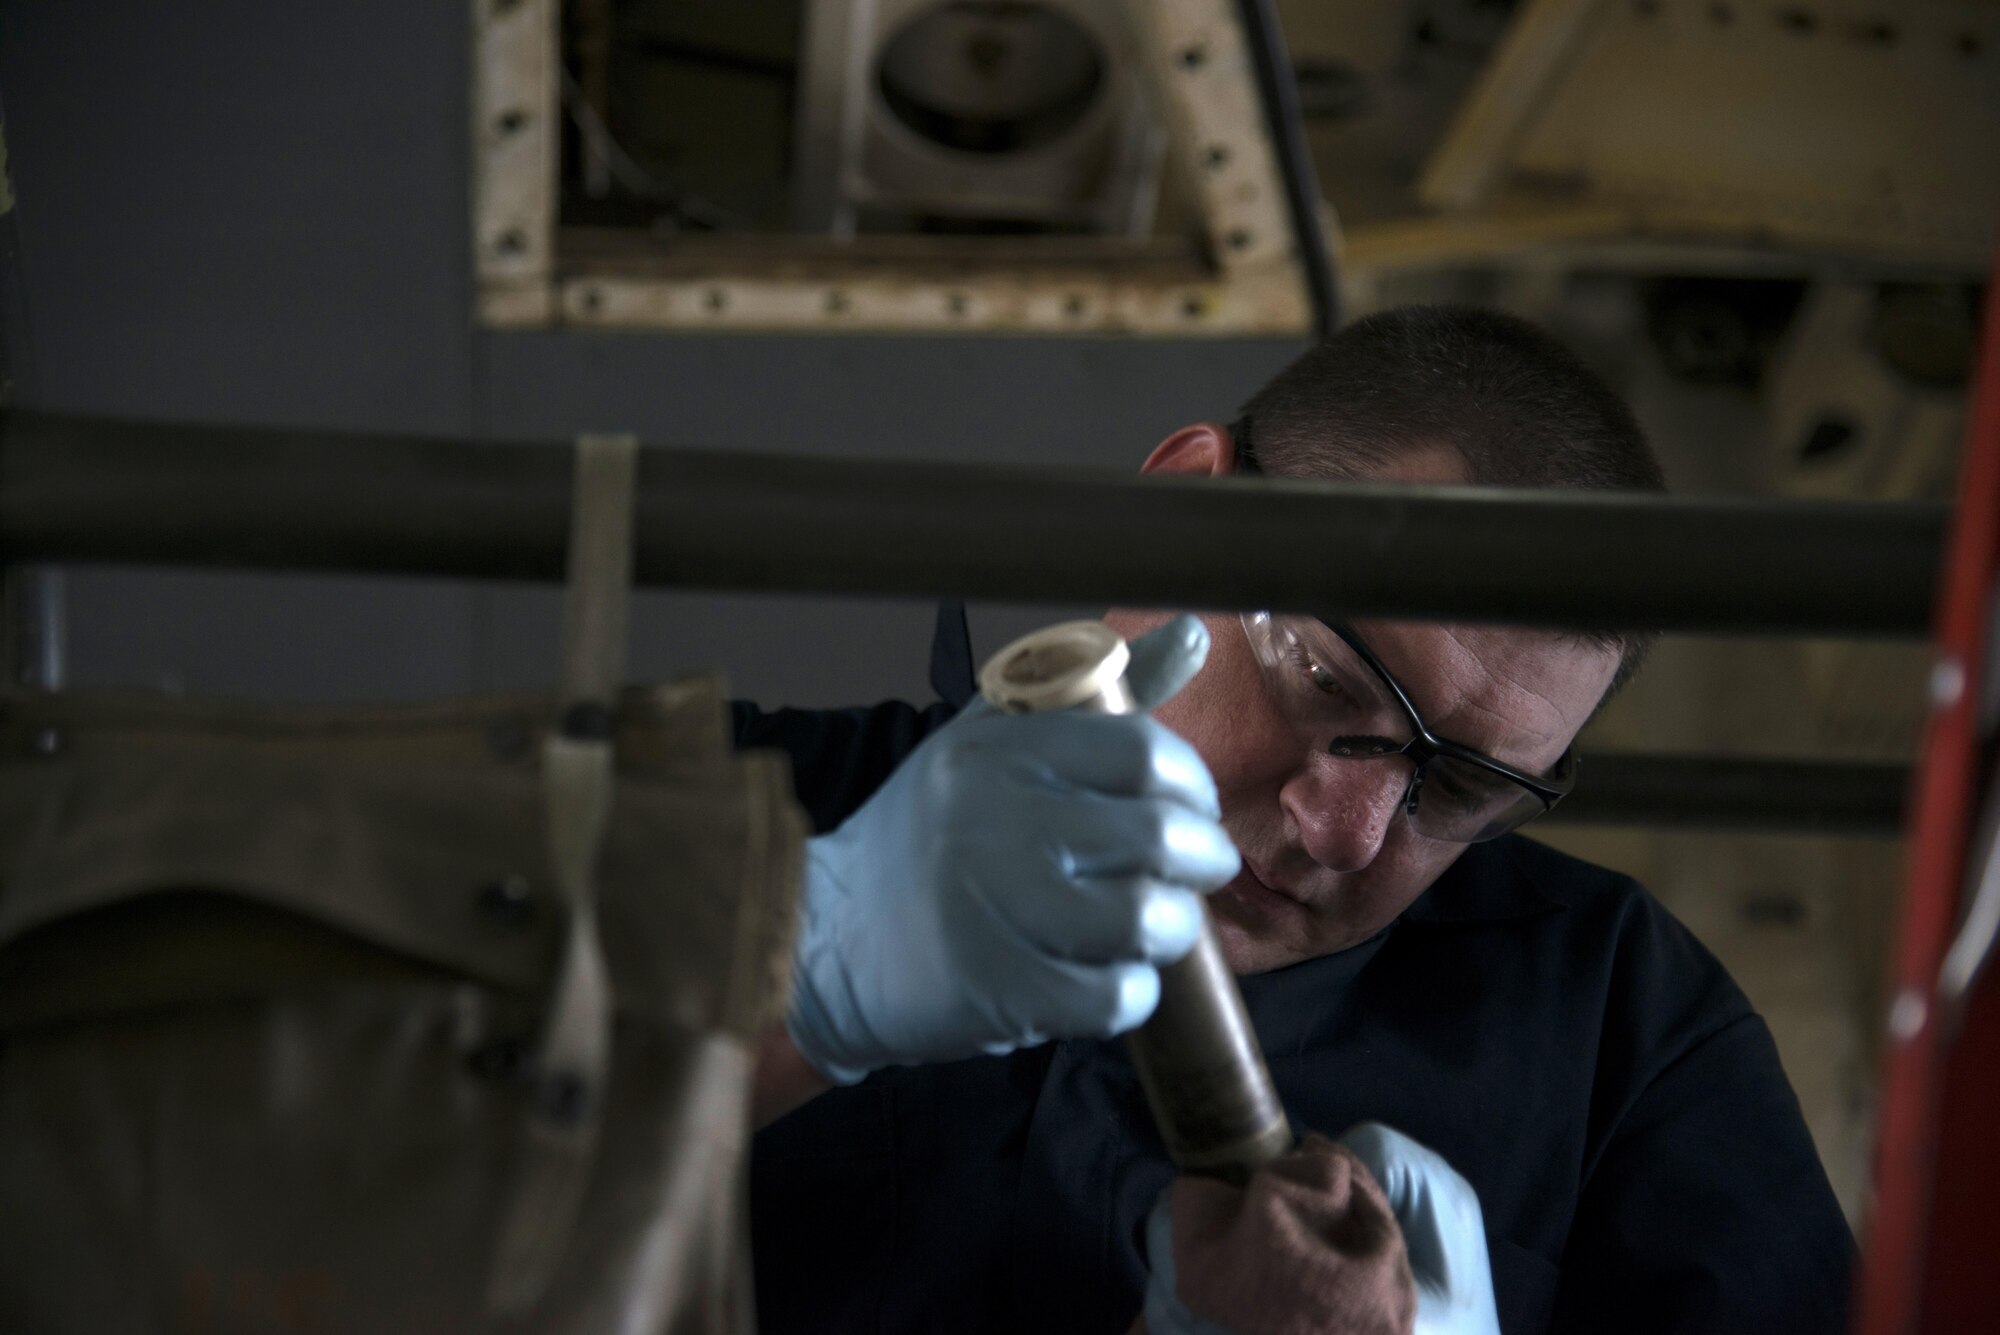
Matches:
[470,0,1330,338]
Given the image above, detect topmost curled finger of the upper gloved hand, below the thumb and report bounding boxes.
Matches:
[976,711,1222,815]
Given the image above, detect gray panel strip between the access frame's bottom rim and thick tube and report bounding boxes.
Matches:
[488,334,1300,468]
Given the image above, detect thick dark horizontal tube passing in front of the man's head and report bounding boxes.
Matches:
[0,412,1946,636]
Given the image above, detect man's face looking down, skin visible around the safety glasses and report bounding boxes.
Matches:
[1108,435,1618,973]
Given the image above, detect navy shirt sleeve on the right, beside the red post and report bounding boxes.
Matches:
[1552,905,1854,1335]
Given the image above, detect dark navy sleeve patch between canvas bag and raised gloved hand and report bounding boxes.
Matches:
[730,699,954,833]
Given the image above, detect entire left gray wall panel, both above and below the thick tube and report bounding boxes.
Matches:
[0,0,478,699]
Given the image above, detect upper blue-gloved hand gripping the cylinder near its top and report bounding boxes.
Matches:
[786,616,1240,1083]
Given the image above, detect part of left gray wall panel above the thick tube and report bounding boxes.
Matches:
[0,0,472,432]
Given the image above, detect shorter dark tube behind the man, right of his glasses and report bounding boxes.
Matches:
[1548,749,1910,837]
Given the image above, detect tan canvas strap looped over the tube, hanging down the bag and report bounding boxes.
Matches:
[488,436,638,1313]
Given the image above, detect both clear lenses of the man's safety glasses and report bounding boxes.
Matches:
[1244,612,1546,843]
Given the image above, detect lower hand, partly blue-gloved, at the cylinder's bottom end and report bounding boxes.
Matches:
[1142,1121,1500,1335]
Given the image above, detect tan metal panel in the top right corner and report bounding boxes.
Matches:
[1420,0,2000,272]
